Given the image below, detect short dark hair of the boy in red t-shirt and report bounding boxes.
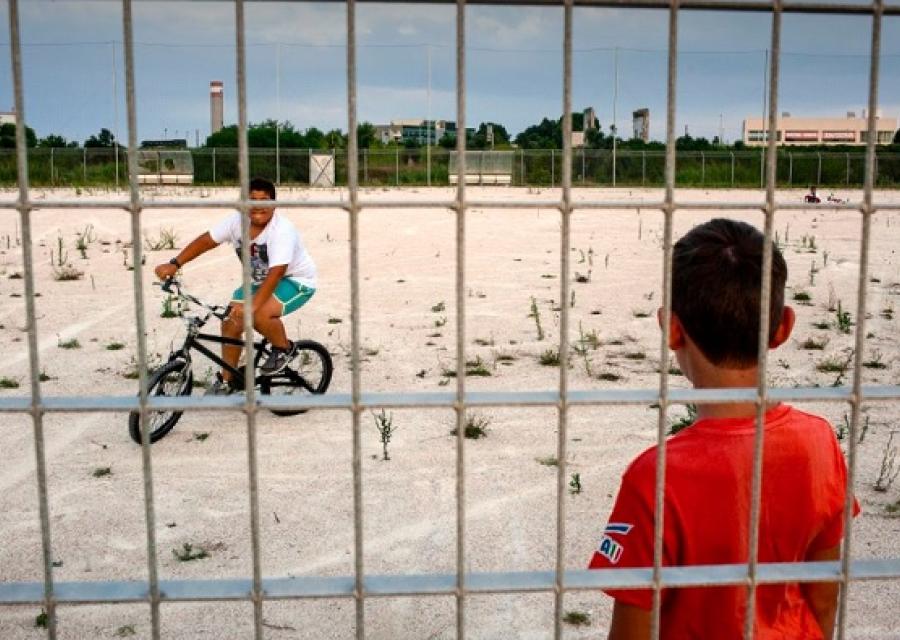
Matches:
[672,218,787,367]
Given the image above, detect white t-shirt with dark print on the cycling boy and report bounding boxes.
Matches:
[209,211,317,289]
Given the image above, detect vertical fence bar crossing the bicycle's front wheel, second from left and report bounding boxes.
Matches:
[116,0,160,640]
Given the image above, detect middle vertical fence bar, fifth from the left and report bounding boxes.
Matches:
[454,0,466,640]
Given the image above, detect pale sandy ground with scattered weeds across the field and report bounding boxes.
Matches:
[0,189,900,639]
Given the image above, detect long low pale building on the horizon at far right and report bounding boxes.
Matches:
[743,110,897,147]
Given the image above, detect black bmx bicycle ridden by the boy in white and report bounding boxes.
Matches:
[128,279,334,444]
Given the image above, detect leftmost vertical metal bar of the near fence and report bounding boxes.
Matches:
[8,0,56,640]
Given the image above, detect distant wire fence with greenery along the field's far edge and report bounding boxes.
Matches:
[10,147,900,188]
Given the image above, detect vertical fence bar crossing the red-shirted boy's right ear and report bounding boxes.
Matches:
[744,6,781,640]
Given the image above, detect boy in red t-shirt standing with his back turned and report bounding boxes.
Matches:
[590,218,858,640]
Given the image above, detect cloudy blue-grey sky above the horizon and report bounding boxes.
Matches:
[0,0,900,144]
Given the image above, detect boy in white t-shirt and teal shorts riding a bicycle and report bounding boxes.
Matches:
[155,178,317,395]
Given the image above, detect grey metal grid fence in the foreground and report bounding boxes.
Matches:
[0,0,900,638]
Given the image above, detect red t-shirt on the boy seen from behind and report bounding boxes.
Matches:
[590,405,859,640]
